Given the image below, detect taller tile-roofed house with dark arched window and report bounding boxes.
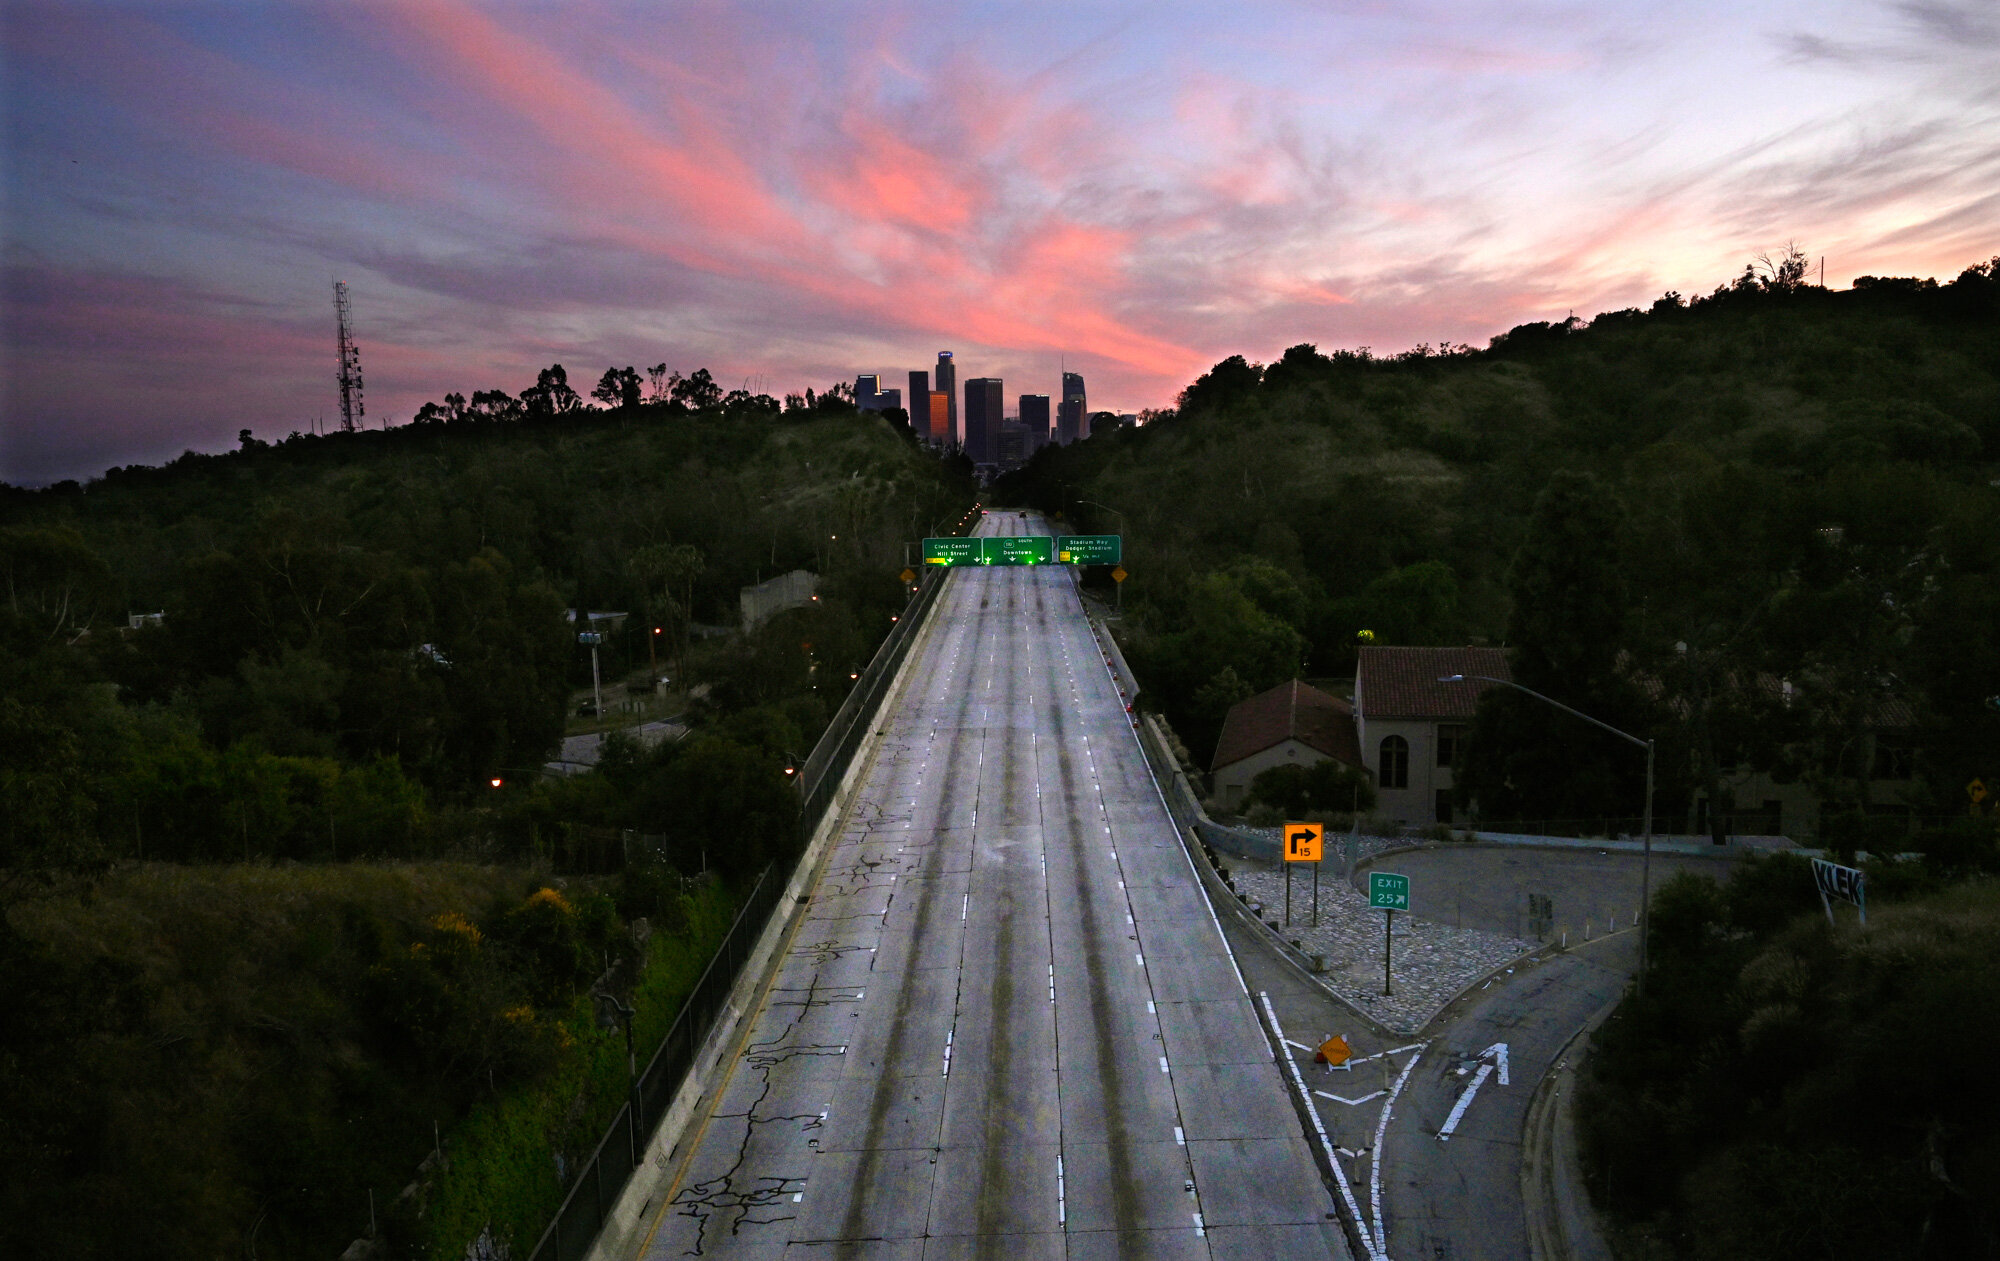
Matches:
[1354,647,1512,825]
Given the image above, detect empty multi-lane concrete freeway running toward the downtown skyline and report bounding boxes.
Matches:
[640,512,1348,1261]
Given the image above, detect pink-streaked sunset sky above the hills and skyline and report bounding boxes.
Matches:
[0,0,2000,484]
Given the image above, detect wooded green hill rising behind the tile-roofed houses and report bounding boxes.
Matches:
[994,258,2000,833]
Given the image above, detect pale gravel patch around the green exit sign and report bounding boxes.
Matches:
[1222,837,1536,1033]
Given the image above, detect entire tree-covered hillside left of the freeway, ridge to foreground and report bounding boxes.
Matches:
[0,390,974,1261]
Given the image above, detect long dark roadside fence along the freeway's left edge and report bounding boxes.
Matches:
[530,570,946,1261]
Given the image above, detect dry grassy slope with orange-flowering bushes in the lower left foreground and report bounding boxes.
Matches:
[0,863,732,1261]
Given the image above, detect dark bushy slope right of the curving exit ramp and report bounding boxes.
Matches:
[1578,857,2000,1261]
